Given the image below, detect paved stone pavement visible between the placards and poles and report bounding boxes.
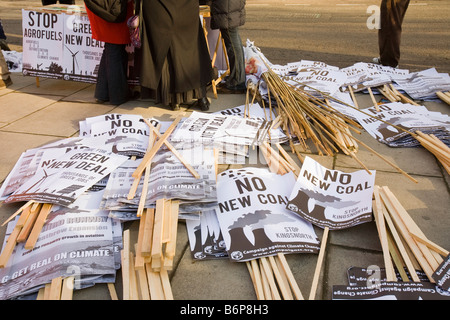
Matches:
[0,0,450,300]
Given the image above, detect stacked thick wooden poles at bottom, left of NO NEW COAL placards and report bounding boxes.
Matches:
[121,199,178,300]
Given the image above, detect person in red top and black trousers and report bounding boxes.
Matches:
[84,0,134,105]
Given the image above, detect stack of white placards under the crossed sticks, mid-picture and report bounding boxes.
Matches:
[101,144,217,220]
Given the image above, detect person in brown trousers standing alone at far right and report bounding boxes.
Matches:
[374,0,409,68]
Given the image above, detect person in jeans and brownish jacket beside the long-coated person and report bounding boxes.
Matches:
[211,0,246,93]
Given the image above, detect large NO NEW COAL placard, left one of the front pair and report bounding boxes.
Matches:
[216,168,319,261]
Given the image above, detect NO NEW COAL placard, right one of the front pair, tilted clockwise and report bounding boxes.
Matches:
[287,157,375,230]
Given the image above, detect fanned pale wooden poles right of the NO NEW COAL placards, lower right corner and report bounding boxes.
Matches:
[373,186,449,283]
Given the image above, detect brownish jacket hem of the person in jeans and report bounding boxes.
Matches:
[211,0,245,29]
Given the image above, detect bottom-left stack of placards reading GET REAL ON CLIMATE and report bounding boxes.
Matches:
[0,206,122,300]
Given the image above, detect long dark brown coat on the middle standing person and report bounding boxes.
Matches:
[136,0,212,93]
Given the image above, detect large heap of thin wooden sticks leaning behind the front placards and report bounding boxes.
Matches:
[255,67,417,183]
